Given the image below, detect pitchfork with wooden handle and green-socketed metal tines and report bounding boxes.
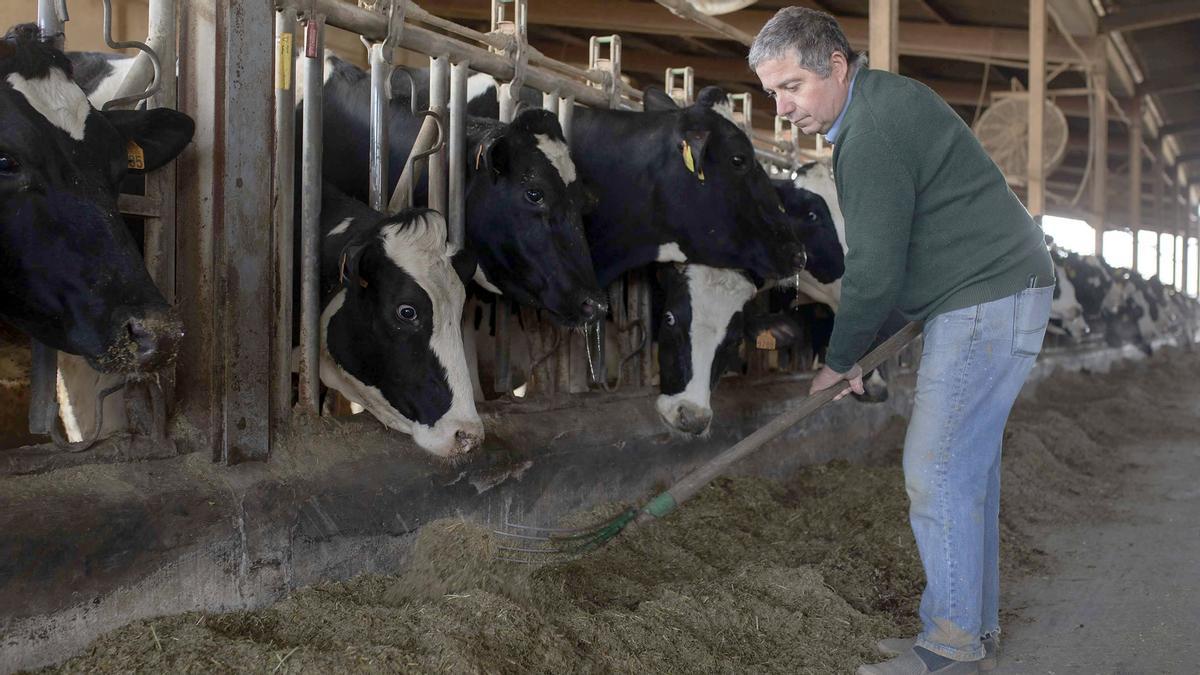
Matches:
[493,322,922,565]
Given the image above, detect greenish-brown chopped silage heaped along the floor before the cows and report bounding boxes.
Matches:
[42,352,1200,674]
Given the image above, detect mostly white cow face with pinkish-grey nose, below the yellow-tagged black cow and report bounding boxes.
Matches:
[655,264,755,435]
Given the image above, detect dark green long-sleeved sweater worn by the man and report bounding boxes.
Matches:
[827,70,1054,372]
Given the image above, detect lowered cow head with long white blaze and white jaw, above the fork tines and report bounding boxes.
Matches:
[320,209,484,459]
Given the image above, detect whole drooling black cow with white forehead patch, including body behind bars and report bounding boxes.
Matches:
[314,53,606,327]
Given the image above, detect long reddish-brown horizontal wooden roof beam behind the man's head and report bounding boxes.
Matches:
[421,0,1094,64]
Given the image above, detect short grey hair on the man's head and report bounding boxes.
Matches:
[750,7,858,78]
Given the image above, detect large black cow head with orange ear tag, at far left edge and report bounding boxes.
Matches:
[0,24,194,372]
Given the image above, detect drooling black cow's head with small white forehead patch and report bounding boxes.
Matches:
[467,109,607,325]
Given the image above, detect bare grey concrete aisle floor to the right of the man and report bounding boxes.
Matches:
[994,432,1200,675]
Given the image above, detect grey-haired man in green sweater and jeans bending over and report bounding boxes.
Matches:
[750,7,1055,675]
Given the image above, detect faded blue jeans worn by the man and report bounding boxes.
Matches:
[904,286,1054,661]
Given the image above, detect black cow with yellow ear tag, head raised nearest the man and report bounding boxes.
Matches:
[469,78,804,286]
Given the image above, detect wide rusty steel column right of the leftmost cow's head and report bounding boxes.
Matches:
[176,0,275,464]
